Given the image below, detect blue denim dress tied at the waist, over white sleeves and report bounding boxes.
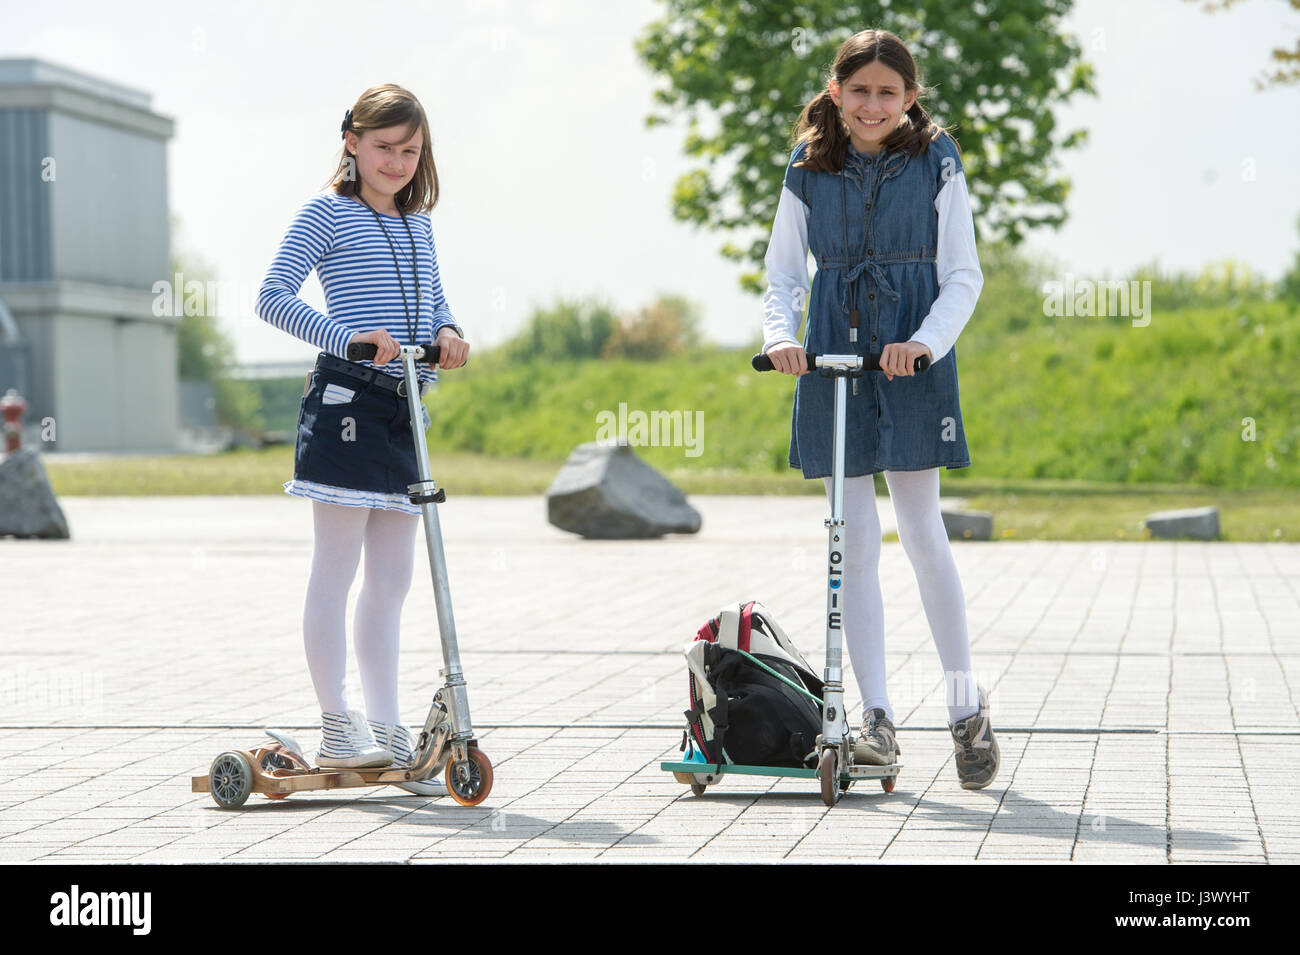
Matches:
[785,135,970,478]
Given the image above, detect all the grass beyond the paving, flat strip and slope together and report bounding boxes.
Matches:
[46,272,1300,541]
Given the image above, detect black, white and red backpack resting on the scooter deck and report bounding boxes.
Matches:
[681,600,823,772]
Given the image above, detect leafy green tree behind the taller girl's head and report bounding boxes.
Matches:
[637,0,1096,291]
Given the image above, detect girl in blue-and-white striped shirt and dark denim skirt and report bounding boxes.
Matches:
[257,84,469,795]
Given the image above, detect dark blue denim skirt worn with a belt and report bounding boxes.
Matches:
[294,352,420,495]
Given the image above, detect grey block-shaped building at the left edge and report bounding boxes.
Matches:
[0,58,179,451]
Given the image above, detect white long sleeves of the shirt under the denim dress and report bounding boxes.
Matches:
[763,172,984,361]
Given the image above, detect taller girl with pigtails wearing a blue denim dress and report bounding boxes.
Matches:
[763,30,998,789]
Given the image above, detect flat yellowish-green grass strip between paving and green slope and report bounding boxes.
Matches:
[43,446,1300,541]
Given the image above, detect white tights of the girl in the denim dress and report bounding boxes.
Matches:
[826,468,979,722]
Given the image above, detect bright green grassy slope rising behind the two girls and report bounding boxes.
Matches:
[387,303,1300,489]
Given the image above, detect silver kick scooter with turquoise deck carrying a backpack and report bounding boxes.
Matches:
[659,352,930,806]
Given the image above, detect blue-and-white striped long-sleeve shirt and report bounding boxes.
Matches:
[256,191,462,382]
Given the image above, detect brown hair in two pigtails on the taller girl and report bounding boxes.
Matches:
[794,30,957,173]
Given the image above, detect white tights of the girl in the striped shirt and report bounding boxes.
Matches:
[303,502,420,724]
